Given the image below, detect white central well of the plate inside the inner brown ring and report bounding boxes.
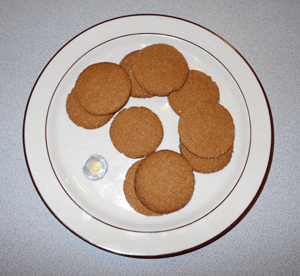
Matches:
[46,34,250,231]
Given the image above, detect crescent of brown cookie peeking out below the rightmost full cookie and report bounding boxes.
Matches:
[179,143,233,173]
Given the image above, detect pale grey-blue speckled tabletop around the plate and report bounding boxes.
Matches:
[0,0,300,275]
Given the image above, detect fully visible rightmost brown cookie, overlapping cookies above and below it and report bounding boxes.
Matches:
[178,102,235,158]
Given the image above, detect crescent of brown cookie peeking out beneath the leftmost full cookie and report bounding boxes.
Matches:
[66,90,114,129]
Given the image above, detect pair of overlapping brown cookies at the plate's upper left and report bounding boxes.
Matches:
[66,62,131,129]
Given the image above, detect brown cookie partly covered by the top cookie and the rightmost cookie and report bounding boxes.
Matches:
[168,70,220,115]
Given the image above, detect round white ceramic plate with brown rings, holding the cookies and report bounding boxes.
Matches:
[24,15,272,257]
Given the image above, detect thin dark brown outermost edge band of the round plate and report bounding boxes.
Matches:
[23,14,274,258]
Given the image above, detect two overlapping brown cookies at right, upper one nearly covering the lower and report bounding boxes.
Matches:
[178,102,235,173]
